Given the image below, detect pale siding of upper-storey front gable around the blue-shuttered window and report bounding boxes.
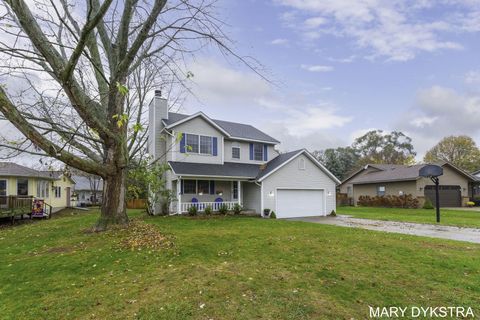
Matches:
[172,117,224,164]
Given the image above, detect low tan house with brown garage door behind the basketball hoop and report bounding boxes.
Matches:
[340,162,477,207]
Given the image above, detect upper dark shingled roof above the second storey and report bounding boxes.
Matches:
[163,112,279,143]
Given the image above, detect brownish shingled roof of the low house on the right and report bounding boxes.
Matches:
[349,163,475,184]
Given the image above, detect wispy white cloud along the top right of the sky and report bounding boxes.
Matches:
[276,0,480,61]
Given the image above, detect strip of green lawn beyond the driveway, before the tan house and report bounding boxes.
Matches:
[337,207,480,228]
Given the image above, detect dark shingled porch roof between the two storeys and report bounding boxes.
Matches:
[168,161,260,179]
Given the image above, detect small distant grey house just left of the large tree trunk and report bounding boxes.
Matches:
[72,175,103,207]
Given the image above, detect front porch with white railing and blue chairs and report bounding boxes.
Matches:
[170,177,258,214]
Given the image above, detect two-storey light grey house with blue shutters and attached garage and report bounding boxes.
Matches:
[148,91,340,218]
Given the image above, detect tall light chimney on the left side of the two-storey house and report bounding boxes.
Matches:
[148,90,168,159]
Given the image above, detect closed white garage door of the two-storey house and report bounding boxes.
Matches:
[275,189,325,218]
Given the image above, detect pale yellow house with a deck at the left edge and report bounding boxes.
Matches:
[0,162,75,212]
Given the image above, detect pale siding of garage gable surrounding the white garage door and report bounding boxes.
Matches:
[262,154,336,214]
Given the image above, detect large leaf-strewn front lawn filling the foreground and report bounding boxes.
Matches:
[0,212,480,319]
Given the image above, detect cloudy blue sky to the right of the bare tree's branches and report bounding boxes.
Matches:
[184,0,480,158]
